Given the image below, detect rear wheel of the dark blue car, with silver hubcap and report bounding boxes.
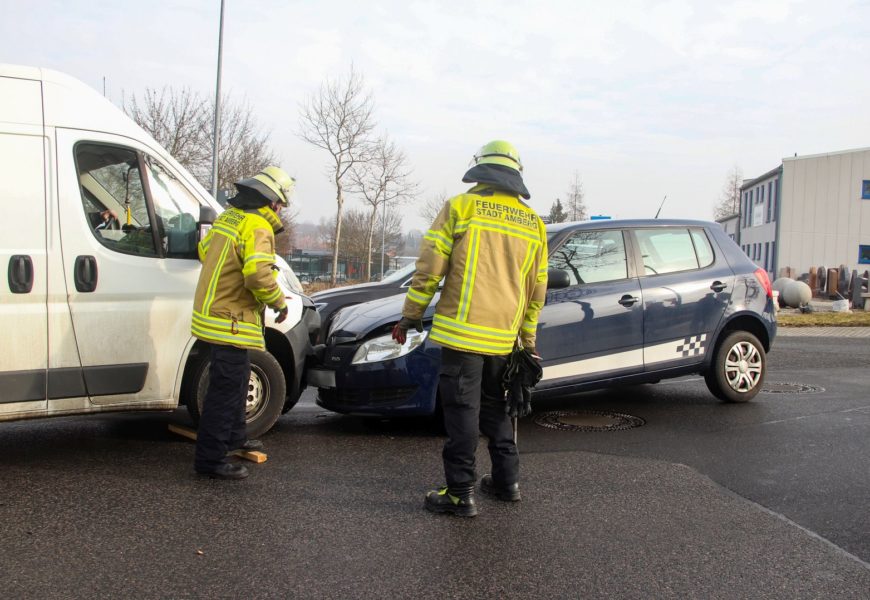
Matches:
[704,331,767,402]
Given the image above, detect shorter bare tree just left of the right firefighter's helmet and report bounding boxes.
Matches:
[348,135,417,279]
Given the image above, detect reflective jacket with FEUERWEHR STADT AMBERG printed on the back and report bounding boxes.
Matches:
[402,184,547,355]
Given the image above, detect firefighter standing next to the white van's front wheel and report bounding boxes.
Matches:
[191,167,295,479]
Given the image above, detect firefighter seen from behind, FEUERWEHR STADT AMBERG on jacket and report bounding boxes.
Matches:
[393,141,547,517]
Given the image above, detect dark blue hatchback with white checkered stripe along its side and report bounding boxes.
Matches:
[307,220,776,416]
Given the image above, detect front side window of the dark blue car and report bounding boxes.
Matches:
[549,229,628,285]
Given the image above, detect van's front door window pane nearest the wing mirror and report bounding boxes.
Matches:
[143,154,199,259]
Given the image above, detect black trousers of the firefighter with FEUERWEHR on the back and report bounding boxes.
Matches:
[439,348,520,492]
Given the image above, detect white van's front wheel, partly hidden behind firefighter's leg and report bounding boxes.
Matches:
[187,350,287,439]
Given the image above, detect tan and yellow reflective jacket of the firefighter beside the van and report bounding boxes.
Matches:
[190,206,286,350]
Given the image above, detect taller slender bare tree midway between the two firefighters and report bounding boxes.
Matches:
[299,66,375,283]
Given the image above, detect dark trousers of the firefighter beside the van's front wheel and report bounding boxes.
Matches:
[193,344,251,470]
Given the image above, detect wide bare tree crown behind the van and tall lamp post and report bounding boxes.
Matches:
[124,87,275,198]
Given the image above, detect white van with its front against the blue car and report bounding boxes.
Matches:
[0,65,320,437]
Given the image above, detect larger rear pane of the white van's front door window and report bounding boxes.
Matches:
[75,143,158,256]
